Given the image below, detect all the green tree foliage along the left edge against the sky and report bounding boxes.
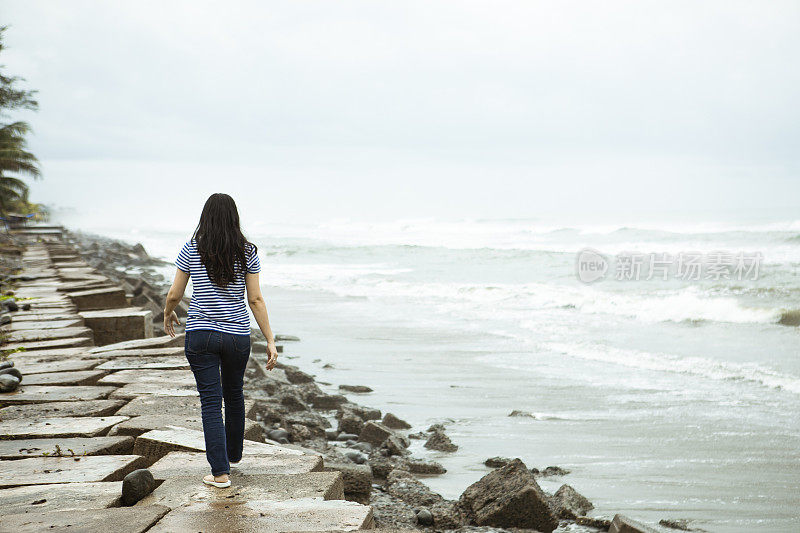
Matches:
[0,26,40,215]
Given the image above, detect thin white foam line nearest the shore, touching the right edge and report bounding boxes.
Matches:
[541,342,800,394]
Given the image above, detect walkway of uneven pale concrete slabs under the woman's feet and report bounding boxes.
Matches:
[0,226,373,533]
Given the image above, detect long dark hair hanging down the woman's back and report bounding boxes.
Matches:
[193,192,258,287]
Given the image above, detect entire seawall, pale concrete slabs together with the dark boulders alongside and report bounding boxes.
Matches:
[0,226,664,531]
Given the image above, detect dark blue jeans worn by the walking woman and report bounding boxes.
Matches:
[184,329,250,476]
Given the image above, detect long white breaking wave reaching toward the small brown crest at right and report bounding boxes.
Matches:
[262,264,784,324]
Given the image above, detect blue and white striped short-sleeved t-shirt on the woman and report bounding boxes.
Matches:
[175,239,261,335]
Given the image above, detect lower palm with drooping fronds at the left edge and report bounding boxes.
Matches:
[0,122,41,214]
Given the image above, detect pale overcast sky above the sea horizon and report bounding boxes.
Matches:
[0,0,800,228]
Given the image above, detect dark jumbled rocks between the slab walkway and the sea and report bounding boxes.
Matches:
[54,232,690,532]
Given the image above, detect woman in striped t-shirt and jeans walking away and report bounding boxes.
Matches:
[164,193,278,487]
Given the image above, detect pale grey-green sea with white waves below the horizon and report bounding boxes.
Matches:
[59,210,800,532]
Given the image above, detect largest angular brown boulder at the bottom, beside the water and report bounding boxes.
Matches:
[459,459,558,533]
